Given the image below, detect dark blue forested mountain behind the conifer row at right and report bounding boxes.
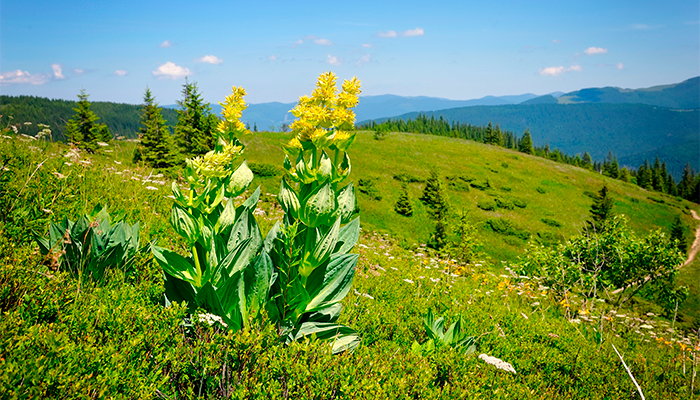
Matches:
[382,103,700,179]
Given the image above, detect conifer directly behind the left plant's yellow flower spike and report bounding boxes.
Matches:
[175,81,218,157]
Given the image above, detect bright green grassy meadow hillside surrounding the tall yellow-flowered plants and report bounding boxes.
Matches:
[0,132,700,399]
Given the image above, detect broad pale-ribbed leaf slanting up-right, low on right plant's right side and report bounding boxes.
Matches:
[306,254,359,312]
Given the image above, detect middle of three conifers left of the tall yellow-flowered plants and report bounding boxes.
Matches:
[138,87,174,168]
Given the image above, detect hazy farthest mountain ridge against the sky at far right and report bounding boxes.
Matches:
[525,77,700,109]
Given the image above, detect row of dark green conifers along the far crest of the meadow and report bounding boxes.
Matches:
[357,114,700,203]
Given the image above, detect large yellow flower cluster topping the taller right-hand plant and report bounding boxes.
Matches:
[290,72,360,147]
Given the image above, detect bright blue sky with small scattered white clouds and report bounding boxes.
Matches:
[0,0,700,104]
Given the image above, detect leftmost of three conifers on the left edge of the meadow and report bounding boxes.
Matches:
[66,89,111,153]
